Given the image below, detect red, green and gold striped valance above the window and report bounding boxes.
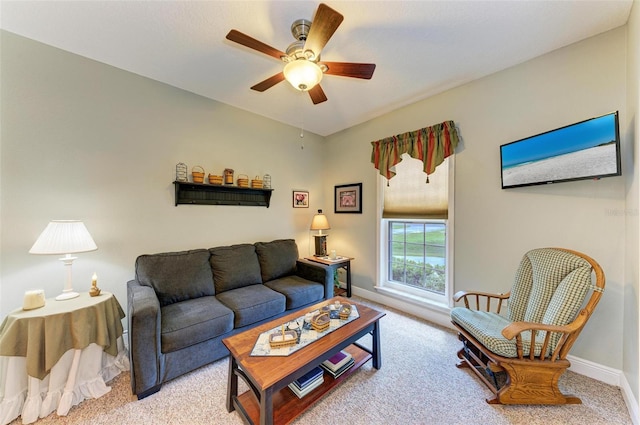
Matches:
[371,121,459,183]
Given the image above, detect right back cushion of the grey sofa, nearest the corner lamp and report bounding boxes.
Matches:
[255,239,298,282]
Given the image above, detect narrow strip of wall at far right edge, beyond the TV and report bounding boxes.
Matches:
[623,1,640,404]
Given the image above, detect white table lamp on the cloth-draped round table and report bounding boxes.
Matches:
[29,220,98,301]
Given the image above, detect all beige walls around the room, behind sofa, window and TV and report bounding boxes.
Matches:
[0,14,640,399]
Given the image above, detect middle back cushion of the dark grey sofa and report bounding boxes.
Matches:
[209,244,262,294]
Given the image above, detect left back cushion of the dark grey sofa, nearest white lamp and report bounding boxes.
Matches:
[136,249,215,306]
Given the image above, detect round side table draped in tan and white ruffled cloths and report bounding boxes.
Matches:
[0,292,129,424]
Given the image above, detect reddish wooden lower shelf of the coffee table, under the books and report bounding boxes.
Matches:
[233,344,372,425]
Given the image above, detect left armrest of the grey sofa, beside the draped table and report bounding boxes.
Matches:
[127,280,162,398]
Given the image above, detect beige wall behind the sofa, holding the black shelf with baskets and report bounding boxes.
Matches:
[0,32,323,316]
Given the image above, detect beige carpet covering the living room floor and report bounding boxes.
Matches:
[12,299,632,425]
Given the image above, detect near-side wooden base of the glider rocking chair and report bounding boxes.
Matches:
[487,360,582,404]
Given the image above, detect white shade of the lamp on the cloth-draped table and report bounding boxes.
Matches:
[29,220,98,254]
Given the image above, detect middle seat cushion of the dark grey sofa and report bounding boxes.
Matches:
[216,284,286,328]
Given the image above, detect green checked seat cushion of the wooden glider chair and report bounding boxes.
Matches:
[451,307,548,358]
